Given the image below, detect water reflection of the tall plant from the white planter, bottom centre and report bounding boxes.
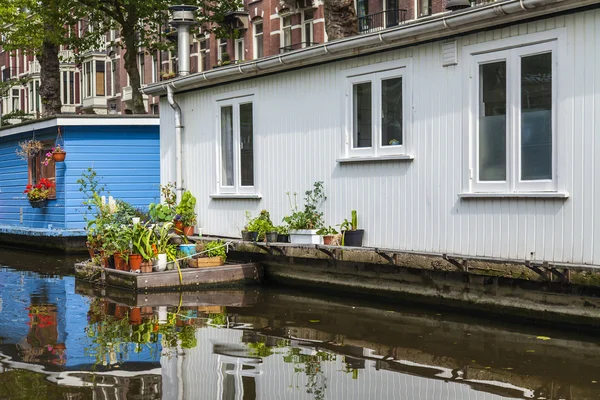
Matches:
[283,347,336,400]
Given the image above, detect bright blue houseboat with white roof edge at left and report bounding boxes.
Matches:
[0,115,160,251]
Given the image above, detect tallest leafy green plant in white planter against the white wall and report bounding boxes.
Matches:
[283,181,327,229]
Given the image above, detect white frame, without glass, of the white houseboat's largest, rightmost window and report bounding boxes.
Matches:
[463,29,565,194]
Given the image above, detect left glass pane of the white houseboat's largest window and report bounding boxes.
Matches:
[479,61,506,181]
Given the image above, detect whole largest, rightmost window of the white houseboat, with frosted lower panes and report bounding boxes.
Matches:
[470,41,557,192]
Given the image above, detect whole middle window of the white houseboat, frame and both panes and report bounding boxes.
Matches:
[345,61,411,157]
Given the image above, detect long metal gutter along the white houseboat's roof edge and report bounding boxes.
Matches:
[142,0,600,96]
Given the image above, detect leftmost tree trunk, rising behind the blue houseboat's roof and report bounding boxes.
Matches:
[37,40,62,117]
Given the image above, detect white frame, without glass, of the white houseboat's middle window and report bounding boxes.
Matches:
[341,59,413,161]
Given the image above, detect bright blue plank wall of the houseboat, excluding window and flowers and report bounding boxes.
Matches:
[0,120,160,229]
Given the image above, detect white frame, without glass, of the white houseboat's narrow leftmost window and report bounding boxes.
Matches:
[213,90,258,195]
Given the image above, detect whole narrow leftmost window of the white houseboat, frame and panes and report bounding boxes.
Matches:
[217,96,254,193]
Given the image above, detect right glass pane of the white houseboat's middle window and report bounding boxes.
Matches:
[381,78,402,146]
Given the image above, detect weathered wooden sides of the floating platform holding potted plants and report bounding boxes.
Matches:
[75,263,263,292]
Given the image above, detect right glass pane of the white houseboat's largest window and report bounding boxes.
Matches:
[521,53,552,181]
